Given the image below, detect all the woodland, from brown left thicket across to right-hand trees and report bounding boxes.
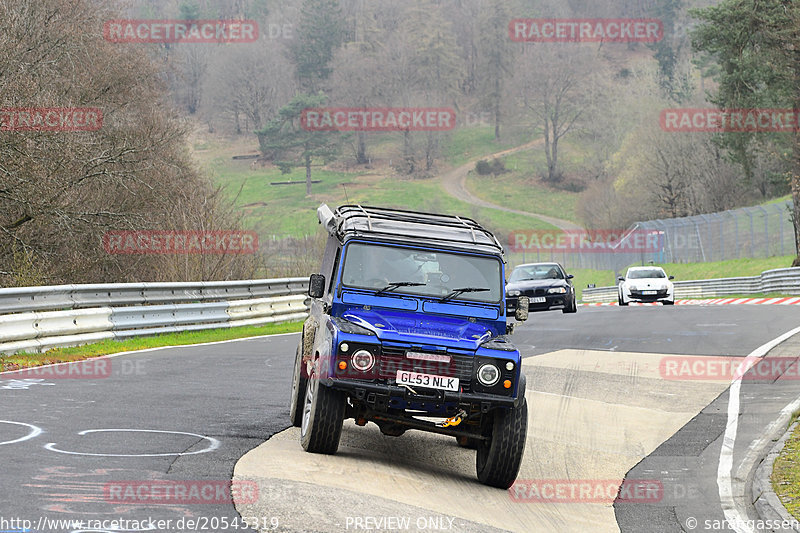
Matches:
[0,0,800,285]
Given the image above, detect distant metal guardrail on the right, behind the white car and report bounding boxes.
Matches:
[582,267,800,303]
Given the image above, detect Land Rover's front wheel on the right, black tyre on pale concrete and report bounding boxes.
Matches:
[475,400,528,489]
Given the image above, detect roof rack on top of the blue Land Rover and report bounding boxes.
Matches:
[320,204,503,253]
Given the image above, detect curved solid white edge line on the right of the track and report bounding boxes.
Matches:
[717,327,800,533]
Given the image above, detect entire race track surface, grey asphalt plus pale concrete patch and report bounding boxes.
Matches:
[0,305,800,533]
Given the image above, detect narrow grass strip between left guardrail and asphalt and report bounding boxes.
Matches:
[0,322,303,371]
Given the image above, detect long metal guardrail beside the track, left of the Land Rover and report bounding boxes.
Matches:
[0,278,308,354]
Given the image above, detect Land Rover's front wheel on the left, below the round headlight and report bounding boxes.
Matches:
[300,360,346,455]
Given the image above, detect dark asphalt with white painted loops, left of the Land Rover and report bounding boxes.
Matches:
[0,335,297,533]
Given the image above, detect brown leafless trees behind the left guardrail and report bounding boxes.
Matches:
[0,0,253,285]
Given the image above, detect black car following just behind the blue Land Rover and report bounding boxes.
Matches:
[506,263,578,316]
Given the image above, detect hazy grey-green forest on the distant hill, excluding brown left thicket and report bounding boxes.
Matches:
[125,0,792,227]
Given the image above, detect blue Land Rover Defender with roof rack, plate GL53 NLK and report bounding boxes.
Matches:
[290,204,528,488]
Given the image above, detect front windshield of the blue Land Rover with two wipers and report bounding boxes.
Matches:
[342,243,503,303]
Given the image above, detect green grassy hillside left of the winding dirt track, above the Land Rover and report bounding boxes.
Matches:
[194,128,552,239]
